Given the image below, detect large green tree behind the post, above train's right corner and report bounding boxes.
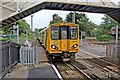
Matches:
[66,12,97,36]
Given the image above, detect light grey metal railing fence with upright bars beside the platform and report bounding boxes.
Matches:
[20,46,35,67]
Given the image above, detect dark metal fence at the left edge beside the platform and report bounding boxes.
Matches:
[0,41,20,79]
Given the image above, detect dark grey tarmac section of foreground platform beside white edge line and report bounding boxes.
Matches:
[27,63,58,80]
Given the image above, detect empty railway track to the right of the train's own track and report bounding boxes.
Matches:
[78,53,119,80]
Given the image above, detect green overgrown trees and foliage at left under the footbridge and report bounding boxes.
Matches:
[0,19,34,45]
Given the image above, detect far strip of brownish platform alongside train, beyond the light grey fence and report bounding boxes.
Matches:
[36,46,48,63]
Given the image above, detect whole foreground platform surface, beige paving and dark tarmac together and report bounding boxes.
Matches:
[4,63,59,80]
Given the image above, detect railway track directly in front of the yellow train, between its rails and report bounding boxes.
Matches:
[54,62,89,80]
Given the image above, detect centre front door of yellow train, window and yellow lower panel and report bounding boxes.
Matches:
[60,26,68,51]
